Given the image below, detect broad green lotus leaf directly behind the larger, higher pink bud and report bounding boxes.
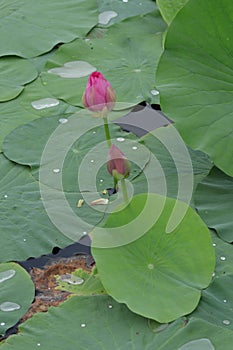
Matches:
[42,11,165,105]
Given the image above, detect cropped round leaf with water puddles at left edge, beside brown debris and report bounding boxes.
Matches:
[0,262,34,336]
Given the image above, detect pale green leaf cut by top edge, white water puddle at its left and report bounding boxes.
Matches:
[98,0,157,25]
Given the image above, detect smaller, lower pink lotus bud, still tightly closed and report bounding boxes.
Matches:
[107,144,130,181]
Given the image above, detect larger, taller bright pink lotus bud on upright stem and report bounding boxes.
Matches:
[82,72,116,112]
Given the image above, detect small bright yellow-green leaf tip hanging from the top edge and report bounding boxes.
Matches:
[157,0,188,24]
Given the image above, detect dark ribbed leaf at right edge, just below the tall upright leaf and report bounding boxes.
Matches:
[195,168,233,242]
